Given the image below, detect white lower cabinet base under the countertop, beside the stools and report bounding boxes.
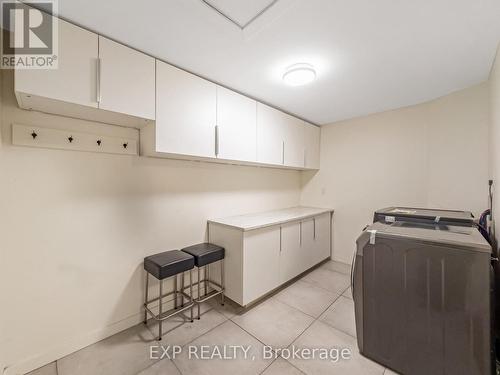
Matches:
[209,211,332,306]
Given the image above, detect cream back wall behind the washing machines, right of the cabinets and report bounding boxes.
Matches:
[301,84,489,262]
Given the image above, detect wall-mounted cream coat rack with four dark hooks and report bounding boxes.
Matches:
[12,124,139,155]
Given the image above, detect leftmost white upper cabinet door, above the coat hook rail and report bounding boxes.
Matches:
[15,20,98,108]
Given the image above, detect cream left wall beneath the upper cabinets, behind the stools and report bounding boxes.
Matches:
[0,74,300,373]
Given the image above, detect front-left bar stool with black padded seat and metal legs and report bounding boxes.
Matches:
[144,250,194,340]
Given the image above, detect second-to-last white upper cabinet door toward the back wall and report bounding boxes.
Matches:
[283,113,305,167]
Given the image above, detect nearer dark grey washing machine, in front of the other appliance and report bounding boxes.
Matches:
[351,221,492,375]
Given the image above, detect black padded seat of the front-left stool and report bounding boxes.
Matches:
[144,250,194,280]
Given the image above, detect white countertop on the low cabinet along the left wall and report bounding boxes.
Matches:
[208,206,333,231]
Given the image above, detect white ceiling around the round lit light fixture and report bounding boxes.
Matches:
[47,0,500,124]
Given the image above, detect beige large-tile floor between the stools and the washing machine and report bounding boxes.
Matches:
[26,261,394,375]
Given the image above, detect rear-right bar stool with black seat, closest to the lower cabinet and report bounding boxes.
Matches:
[181,243,224,319]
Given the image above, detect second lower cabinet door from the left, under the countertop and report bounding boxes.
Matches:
[280,222,304,283]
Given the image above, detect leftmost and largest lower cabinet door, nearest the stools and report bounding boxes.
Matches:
[243,227,280,305]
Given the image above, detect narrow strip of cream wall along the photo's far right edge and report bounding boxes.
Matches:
[489,46,500,241]
